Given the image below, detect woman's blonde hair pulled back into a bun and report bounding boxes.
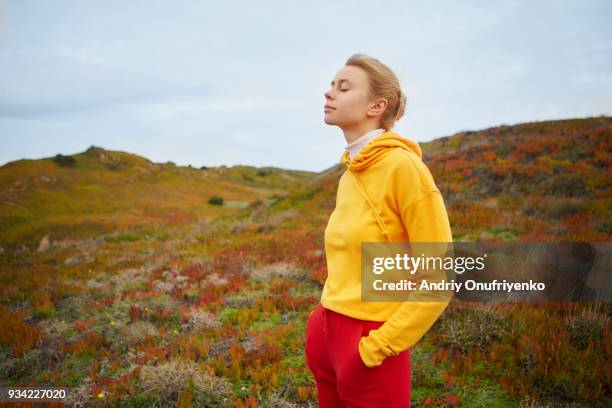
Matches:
[344,54,406,130]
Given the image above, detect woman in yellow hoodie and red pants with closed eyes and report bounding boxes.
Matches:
[305,54,452,408]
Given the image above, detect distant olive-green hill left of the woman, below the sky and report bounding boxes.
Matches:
[0,146,311,246]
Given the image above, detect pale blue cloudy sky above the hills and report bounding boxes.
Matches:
[0,0,612,172]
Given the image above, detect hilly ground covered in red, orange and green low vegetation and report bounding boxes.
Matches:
[0,117,612,408]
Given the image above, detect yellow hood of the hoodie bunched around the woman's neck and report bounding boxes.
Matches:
[340,130,423,171]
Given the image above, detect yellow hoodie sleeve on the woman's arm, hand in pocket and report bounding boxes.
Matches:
[359,155,453,367]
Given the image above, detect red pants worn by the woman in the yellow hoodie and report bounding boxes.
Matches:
[306,303,411,408]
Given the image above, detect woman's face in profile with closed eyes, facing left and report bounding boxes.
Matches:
[323,65,375,129]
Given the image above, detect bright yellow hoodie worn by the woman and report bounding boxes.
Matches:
[321,130,453,367]
